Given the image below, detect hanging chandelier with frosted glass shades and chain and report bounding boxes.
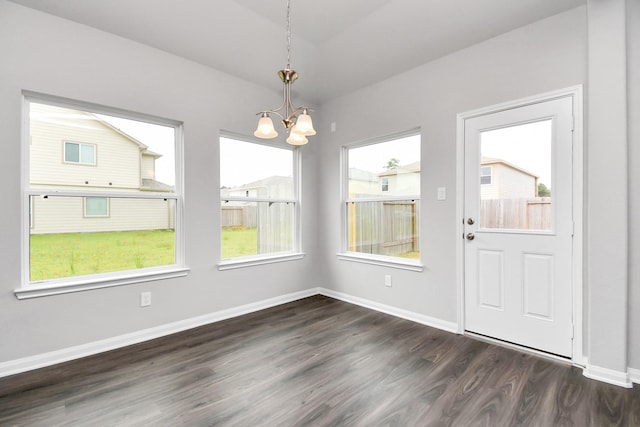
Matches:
[253,0,316,145]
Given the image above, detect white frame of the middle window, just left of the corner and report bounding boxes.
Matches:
[218,131,305,271]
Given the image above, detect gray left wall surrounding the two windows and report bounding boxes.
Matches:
[0,0,325,362]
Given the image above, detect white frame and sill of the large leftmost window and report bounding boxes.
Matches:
[14,91,189,299]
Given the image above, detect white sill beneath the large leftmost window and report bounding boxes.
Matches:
[14,267,189,299]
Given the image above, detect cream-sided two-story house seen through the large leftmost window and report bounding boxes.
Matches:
[29,104,175,234]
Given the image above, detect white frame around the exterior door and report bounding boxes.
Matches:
[455,85,585,366]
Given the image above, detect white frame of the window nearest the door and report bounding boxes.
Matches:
[336,128,424,271]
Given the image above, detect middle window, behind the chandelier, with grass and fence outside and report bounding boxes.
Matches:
[220,136,300,269]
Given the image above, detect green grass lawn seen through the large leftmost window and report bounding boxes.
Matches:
[30,230,175,281]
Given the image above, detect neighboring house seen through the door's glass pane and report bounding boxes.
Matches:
[480,157,538,200]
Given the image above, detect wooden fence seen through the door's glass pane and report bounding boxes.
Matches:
[480,197,551,230]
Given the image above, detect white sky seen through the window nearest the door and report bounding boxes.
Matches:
[349,135,420,173]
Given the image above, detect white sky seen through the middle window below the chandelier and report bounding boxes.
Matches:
[220,137,293,188]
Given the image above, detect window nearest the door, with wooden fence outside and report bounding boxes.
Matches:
[343,131,421,264]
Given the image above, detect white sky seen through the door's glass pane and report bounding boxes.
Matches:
[480,120,552,188]
